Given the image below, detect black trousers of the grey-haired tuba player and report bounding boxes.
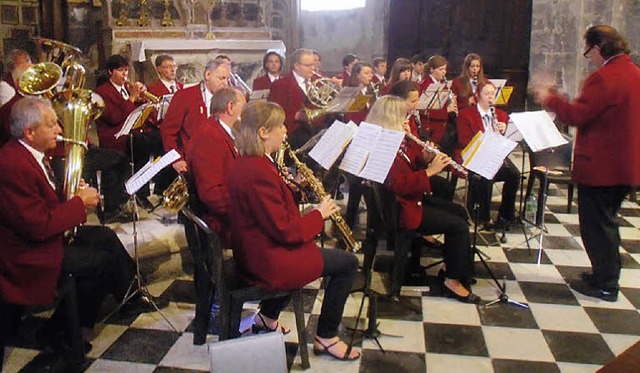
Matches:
[62,226,135,328]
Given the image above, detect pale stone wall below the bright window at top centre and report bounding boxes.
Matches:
[300,0,389,73]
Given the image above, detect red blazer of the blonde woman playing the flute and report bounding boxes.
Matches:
[384,141,431,229]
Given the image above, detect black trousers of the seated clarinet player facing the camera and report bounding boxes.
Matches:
[467,159,520,223]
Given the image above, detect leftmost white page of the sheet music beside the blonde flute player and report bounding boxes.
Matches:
[309,120,358,170]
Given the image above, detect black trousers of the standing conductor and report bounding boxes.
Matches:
[578,185,631,289]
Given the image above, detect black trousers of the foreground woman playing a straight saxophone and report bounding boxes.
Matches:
[260,249,358,338]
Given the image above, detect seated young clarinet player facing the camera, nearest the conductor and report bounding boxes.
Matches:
[458,80,520,230]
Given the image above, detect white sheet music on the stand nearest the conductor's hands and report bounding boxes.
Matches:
[510,110,567,152]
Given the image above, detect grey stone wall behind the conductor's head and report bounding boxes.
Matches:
[529,0,640,97]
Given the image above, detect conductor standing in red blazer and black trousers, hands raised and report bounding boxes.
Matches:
[534,25,640,301]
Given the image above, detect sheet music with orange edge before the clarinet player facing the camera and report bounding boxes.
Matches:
[462,132,518,180]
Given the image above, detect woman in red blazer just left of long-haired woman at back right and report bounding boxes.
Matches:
[420,55,458,144]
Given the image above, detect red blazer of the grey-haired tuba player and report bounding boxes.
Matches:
[0,139,87,305]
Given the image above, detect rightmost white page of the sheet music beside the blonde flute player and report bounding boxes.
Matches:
[358,129,404,183]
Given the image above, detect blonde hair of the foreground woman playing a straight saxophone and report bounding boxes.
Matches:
[234,100,285,157]
